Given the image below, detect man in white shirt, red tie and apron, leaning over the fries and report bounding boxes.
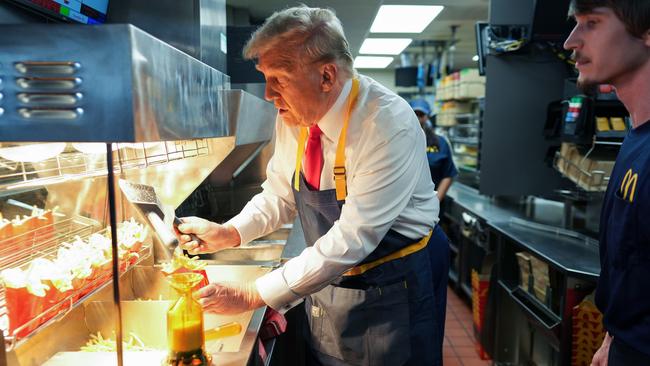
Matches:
[179,6,449,366]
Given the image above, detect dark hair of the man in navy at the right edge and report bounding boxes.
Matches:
[569,0,650,38]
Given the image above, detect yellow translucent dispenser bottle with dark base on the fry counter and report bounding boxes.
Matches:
[167,272,212,365]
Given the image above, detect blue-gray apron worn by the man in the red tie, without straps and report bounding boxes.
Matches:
[293,174,449,366]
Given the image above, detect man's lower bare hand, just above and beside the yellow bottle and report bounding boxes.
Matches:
[196,282,264,314]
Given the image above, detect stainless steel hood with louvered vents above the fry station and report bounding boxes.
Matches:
[0,24,232,142]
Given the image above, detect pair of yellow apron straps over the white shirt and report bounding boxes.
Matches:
[293,78,359,201]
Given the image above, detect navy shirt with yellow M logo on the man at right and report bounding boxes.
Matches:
[596,122,650,355]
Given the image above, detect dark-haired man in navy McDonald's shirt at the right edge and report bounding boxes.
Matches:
[564,0,650,366]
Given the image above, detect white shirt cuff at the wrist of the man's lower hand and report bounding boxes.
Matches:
[255,268,303,314]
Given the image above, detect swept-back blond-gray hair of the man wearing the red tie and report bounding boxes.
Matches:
[243,5,354,76]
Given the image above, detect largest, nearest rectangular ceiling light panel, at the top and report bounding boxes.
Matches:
[370,5,444,33]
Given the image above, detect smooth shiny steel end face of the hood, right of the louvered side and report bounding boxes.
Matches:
[129,26,228,141]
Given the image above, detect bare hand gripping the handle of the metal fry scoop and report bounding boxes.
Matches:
[178,216,241,254]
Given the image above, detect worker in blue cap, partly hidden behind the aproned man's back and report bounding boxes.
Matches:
[410,99,458,202]
